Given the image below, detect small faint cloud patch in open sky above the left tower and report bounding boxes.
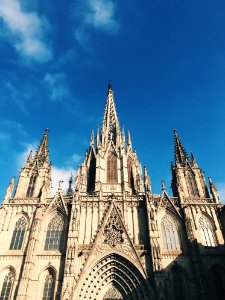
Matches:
[44,73,70,102]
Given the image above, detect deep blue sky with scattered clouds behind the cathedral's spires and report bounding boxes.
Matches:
[0,0,225,201]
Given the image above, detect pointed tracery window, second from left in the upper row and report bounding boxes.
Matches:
[45,215,64,250]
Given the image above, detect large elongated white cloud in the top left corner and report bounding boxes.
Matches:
[0,0,52,62]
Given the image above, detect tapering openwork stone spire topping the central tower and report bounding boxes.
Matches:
[102,83,120,146]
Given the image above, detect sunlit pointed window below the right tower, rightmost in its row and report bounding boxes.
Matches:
[199,217,216,247]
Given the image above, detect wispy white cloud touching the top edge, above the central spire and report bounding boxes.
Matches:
[75,0,120,49]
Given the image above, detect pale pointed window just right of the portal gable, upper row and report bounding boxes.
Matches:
[161,214,181,250]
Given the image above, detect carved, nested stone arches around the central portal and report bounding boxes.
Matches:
[77,253,153,300]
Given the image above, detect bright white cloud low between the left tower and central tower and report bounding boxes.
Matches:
[51,166,76,196]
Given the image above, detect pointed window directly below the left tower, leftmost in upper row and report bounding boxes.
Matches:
[9,217,27,250]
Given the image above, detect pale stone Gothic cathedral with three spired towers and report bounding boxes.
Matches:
[0,84,225,300]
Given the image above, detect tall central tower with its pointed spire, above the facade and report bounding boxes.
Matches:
[75,84,144,194]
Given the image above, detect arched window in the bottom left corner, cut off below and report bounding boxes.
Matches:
[0,267,15,300]
